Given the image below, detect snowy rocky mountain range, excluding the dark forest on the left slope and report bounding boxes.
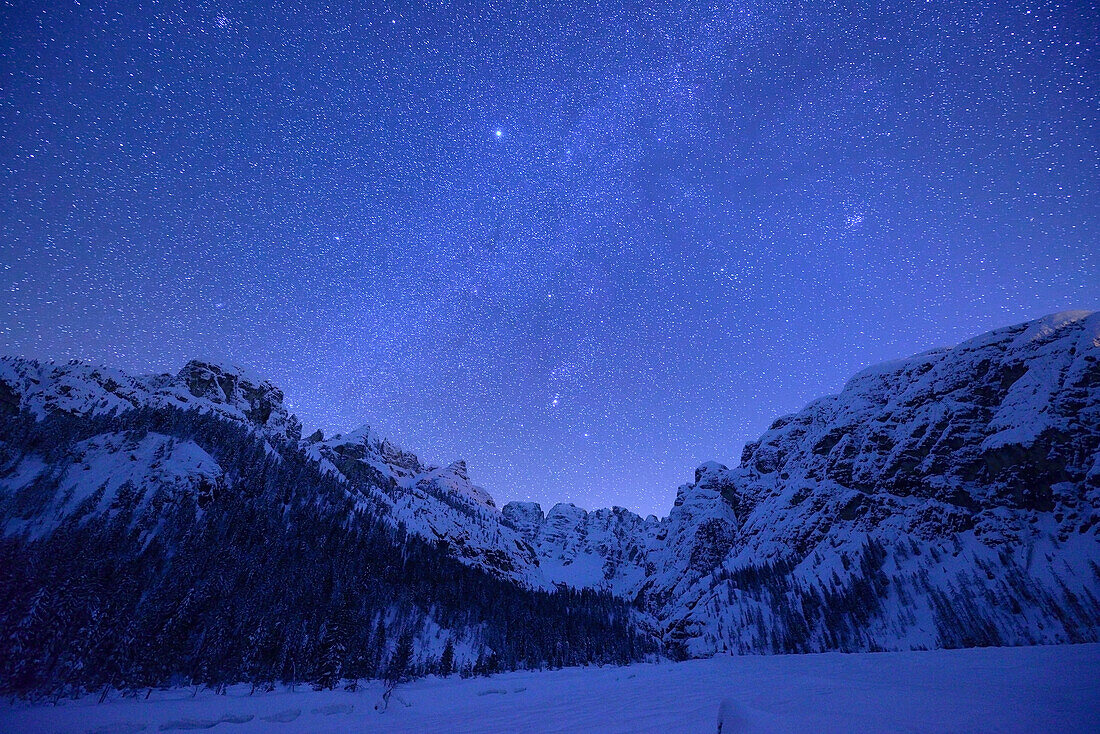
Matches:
[0,311,1100,656]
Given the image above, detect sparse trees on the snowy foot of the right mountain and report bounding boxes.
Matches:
[686,537,1100,657]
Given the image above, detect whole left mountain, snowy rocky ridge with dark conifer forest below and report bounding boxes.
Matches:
[0,359,655,697]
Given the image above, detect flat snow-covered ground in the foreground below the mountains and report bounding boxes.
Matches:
[0,644,1100,734]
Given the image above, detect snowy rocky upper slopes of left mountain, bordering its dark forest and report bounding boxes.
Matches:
[0,358,548,588]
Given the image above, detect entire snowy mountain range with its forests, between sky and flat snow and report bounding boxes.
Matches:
[0,311,1100,690]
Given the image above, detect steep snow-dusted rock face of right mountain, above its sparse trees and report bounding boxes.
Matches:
[732,313,1100,552]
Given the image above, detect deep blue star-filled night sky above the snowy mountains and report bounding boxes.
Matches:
[0,0,1100,515]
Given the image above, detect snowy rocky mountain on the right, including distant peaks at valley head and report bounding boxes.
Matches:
[505,311,1100,656]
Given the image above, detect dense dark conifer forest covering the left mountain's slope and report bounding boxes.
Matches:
[0,409,655,697]
